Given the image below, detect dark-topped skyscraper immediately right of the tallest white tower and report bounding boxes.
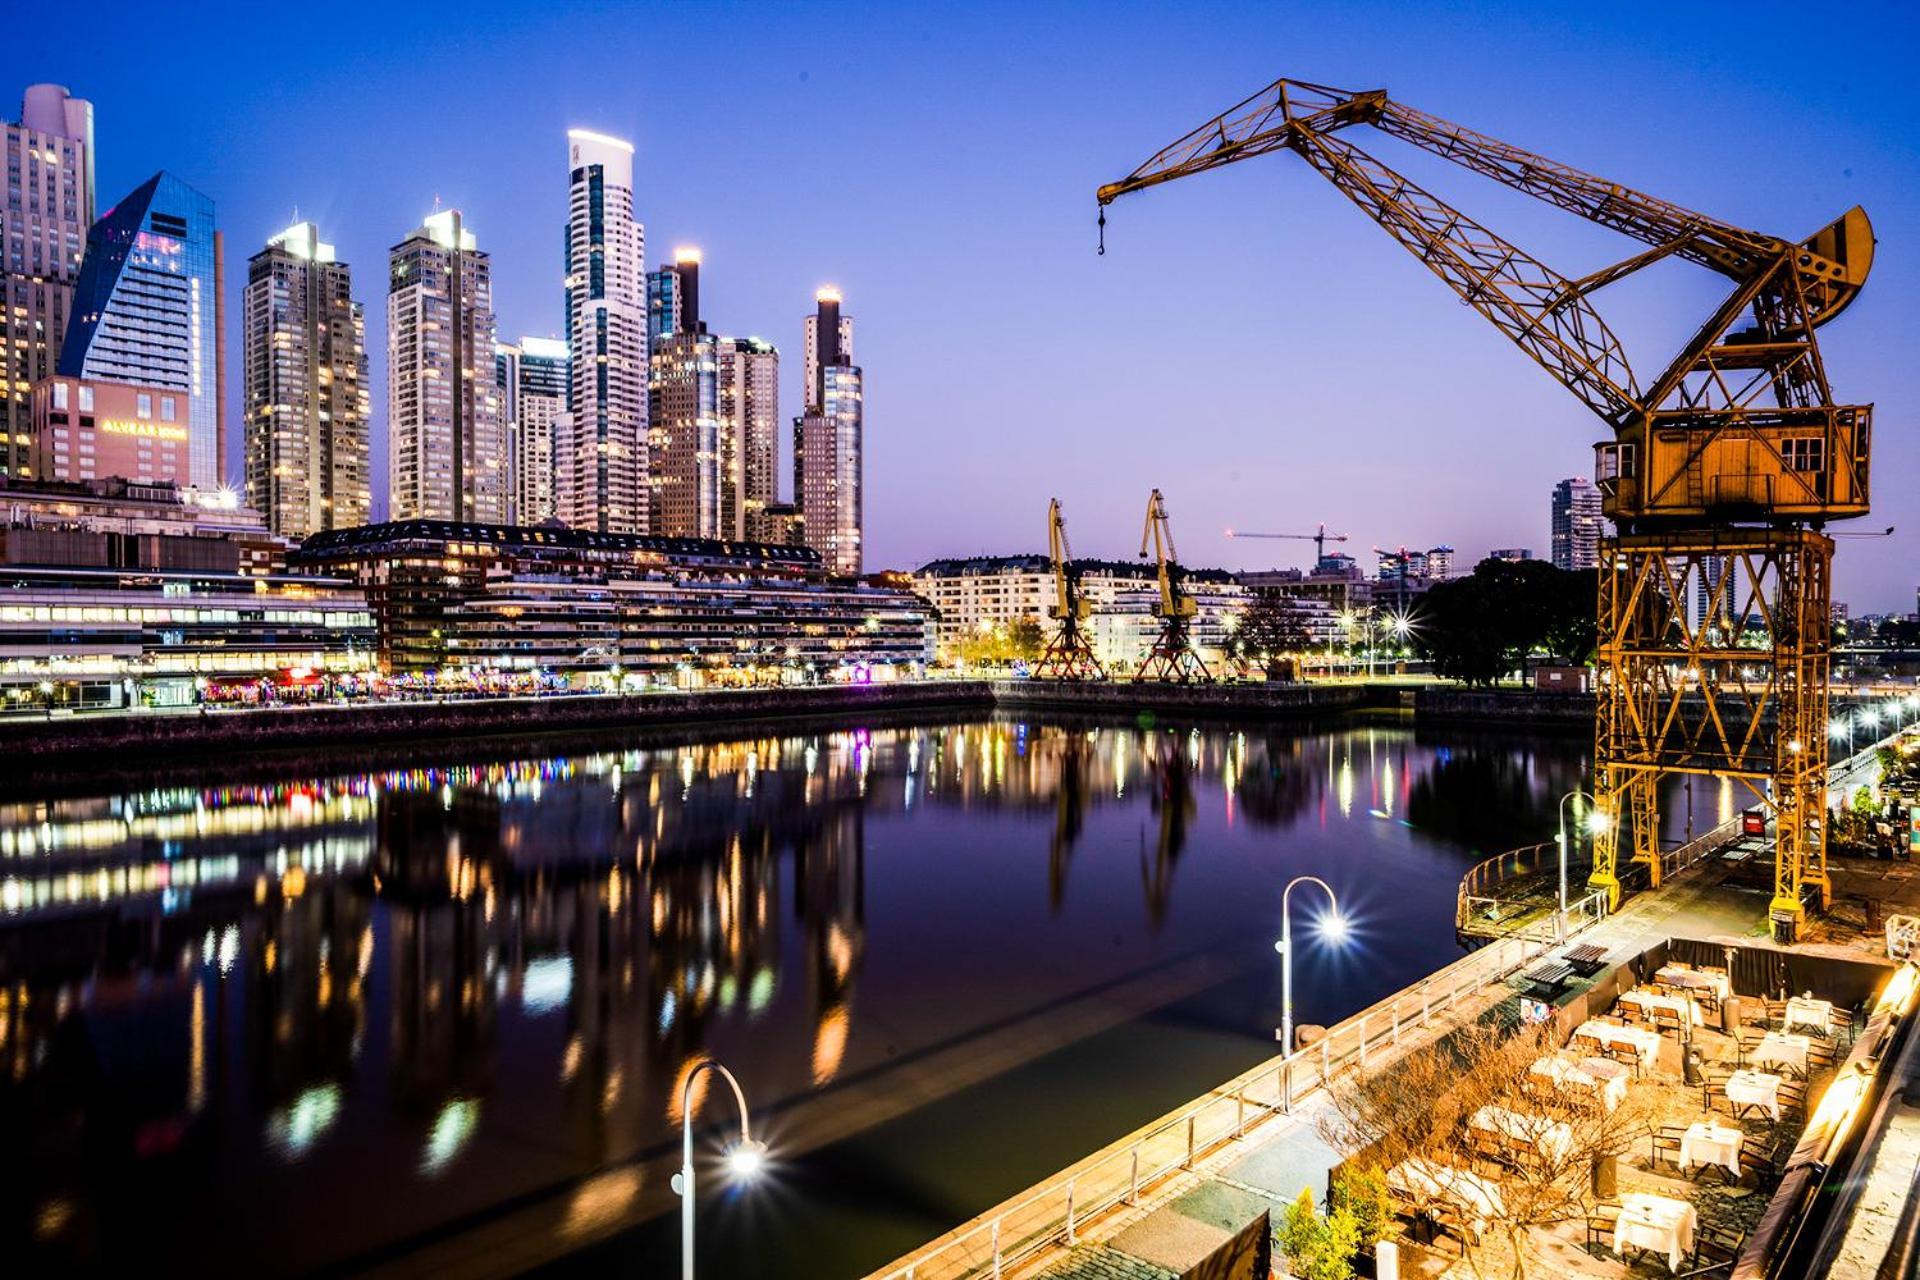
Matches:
[647,249,732,537]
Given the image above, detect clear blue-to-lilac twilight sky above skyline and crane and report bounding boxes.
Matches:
[0,0,1920,612]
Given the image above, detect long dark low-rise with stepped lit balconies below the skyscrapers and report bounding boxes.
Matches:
[292,520,931,687]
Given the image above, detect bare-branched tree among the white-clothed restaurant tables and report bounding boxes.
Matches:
[1321,1017,1649,1278]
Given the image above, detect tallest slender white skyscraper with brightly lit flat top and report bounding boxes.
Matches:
[557,129,649,533]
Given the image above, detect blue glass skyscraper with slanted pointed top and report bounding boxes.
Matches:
[60,173,227,489]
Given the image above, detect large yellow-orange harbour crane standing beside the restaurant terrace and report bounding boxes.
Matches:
[1098,79,1874,938]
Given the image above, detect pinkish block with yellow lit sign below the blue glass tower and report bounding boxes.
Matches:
[31,376,192,489]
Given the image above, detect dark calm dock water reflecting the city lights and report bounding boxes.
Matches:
[0,720,1735,1276]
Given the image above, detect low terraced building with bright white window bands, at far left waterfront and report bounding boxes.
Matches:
[0,480,374,712]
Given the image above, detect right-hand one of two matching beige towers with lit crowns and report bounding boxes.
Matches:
[386,209,509,524]
